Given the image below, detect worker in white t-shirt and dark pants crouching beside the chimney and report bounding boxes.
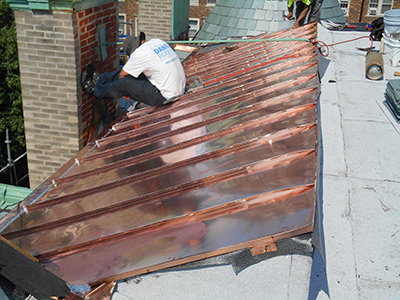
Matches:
[82,36,186,106]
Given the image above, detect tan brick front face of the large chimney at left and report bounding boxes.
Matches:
[15,11,81,188]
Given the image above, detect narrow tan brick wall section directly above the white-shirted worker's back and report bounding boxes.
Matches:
[139,0,172,41]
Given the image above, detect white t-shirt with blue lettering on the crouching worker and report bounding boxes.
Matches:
[123,39,186,99]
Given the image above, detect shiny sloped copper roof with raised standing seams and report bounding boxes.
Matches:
[0,25,318,285]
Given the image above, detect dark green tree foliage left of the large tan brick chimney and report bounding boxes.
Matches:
[0,0,25,169]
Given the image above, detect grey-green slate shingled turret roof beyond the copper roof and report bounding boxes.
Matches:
[194,0,346,40]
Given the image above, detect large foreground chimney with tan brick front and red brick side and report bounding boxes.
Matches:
[15,3,118,188]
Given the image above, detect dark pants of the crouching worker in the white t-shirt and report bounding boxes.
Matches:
[94,71,167,106]
